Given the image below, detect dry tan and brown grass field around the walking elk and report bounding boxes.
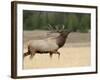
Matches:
[23,31,91,69]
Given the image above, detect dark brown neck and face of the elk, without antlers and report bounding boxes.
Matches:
[56,32,69,48]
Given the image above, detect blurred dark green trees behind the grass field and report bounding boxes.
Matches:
[23,10,91,32]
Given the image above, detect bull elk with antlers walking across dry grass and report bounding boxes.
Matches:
[24,24,71,58]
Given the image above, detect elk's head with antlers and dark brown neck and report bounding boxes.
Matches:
[48,24,71,48]
